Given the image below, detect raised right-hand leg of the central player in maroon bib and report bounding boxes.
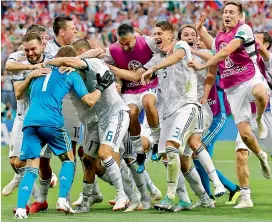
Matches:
[142,89,160,161]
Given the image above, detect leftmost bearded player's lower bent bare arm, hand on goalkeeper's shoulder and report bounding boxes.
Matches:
[13,68,52,100]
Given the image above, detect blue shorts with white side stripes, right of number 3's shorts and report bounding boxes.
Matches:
[202,113,227,156]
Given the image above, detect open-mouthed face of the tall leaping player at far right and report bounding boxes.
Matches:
[223,5,242,31]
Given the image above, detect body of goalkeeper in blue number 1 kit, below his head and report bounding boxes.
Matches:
[14,45,114,219]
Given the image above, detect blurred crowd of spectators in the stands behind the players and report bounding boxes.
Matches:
[1,1,272,120]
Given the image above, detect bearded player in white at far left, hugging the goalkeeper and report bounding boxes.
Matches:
[3,27,52,213]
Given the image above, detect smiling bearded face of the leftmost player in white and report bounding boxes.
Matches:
[23,39,43,63]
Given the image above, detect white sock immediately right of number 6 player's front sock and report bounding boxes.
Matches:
[120,159,134,200]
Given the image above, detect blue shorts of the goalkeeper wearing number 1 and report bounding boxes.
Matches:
[20,126,72,161]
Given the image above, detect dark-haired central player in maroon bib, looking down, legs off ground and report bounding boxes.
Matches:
[104,24,160,173]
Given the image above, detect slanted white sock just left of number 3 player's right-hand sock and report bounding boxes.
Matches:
[184,166,207,198]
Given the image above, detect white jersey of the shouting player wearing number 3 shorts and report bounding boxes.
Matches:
[144,41,198,118]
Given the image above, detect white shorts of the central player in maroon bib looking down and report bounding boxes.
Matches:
[122,88,158,112]
